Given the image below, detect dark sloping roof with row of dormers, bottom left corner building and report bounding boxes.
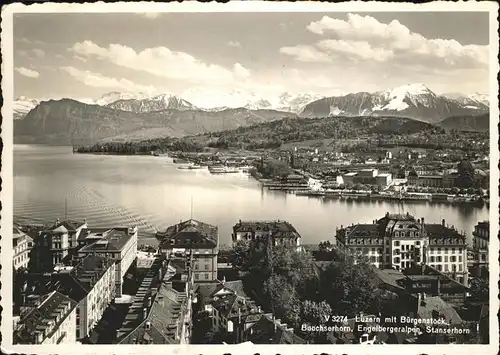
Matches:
[14,291,77,344]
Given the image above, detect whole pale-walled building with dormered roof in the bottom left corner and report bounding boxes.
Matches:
[13,291,77,345]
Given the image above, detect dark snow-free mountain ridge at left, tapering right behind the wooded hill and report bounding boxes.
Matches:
[14,99,296,145]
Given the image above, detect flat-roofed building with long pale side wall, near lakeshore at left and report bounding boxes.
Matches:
[77,227,138,297]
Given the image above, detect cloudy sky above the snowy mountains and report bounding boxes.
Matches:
[14,12,489,107]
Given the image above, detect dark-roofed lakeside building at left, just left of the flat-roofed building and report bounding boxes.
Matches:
[32,219,87,272]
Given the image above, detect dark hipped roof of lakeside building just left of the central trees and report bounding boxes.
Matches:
[156,219,219,249]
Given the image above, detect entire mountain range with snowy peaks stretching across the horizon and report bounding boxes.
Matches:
[14,84,489,144]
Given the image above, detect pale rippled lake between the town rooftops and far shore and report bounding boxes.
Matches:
[14,145,489,244]
